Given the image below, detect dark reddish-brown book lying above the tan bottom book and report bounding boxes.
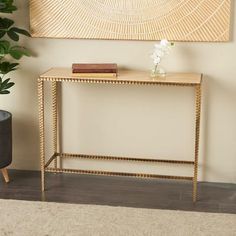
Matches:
[72,63,117,73]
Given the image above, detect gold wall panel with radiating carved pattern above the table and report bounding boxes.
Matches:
[30,0,231,41]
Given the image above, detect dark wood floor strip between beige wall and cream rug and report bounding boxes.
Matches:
[0,170,236,214]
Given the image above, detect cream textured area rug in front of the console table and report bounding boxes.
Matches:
[0,200,236,236]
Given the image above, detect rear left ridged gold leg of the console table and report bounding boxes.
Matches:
[52,81,58,169]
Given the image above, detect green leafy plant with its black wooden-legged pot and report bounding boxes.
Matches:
[0,0,30,182]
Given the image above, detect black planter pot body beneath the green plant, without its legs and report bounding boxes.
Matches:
[0,110,12,169]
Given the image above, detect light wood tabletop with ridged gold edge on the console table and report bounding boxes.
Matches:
[40,67,202,86]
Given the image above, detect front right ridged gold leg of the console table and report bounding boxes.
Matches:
[193,85,201,202]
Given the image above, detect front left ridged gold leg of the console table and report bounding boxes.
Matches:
[38,79,45,191]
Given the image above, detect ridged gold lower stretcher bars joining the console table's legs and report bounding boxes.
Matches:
[44,153,194,181]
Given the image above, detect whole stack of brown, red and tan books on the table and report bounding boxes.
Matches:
[72,63,117,78]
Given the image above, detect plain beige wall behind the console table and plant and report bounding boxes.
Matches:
[0,0,236,183]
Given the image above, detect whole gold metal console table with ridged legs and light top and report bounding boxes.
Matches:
[38,68,202,202]
